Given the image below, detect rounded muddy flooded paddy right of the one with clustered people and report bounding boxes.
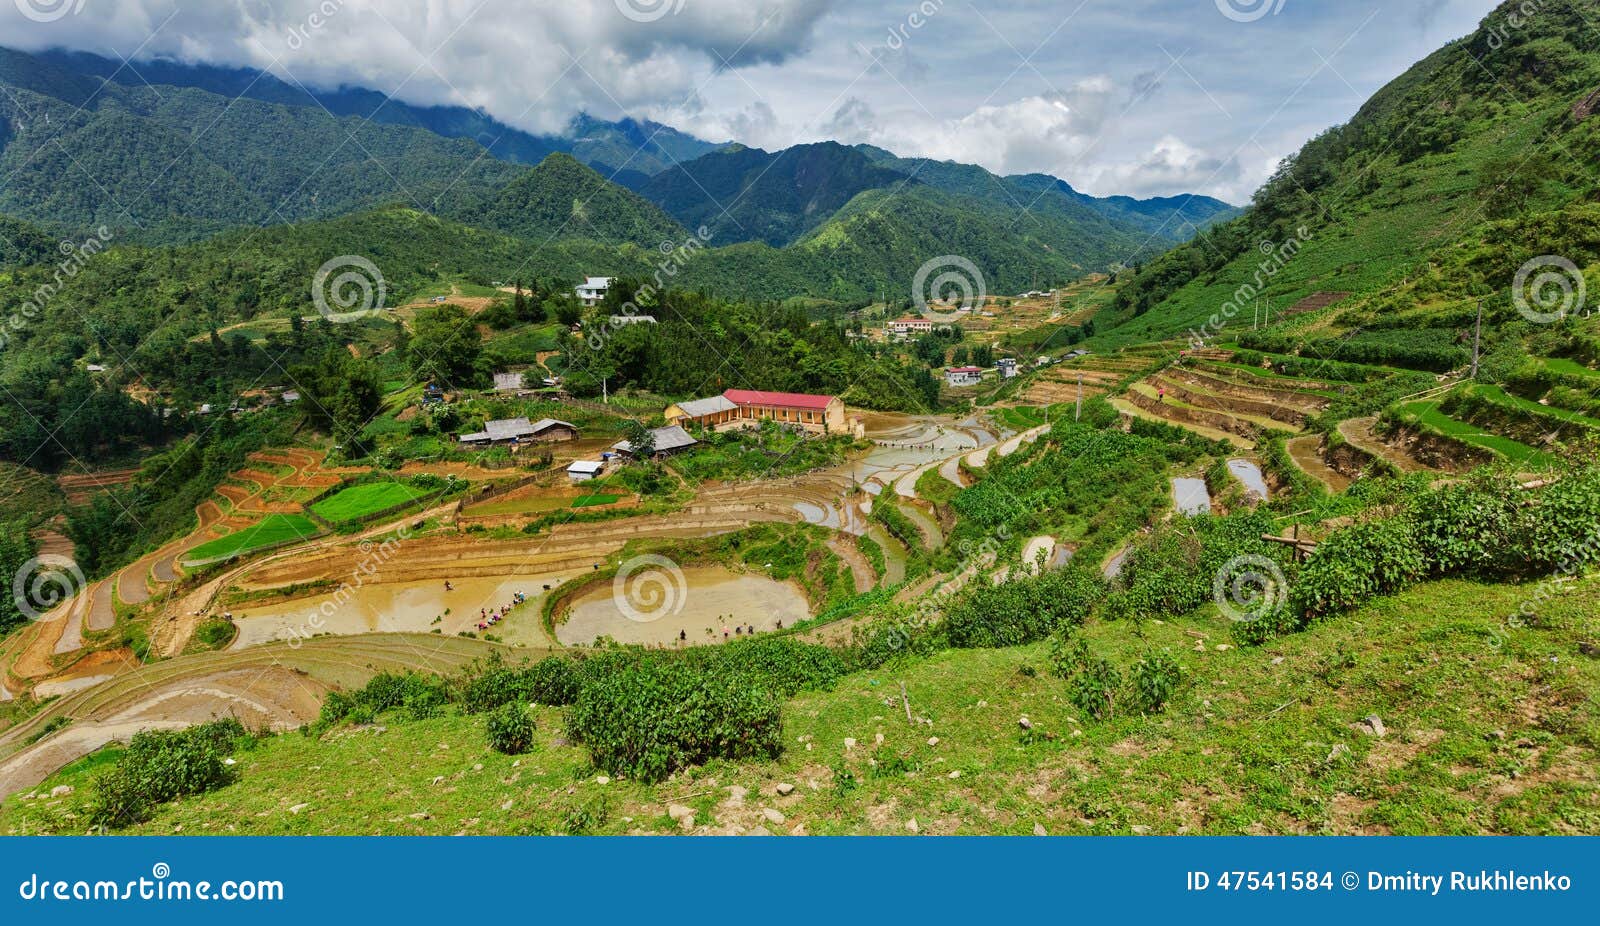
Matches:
[555,566,811,646]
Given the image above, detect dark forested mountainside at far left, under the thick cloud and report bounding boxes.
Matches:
[0,50,518,243]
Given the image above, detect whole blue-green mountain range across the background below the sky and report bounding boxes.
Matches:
[0,50,1232,270]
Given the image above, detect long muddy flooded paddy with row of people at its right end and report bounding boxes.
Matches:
[230,571,582,649]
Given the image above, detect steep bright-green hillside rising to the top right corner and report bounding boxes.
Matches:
[1101,0,1600,344]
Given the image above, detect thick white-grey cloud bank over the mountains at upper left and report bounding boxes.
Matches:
[0,0,835,131]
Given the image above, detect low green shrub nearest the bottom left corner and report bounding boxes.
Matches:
[88,718,248,828]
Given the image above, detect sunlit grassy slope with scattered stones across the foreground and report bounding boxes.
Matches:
[9,579,1600,835]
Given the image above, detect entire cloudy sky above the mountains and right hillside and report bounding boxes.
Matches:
[0,0,1498,203]
